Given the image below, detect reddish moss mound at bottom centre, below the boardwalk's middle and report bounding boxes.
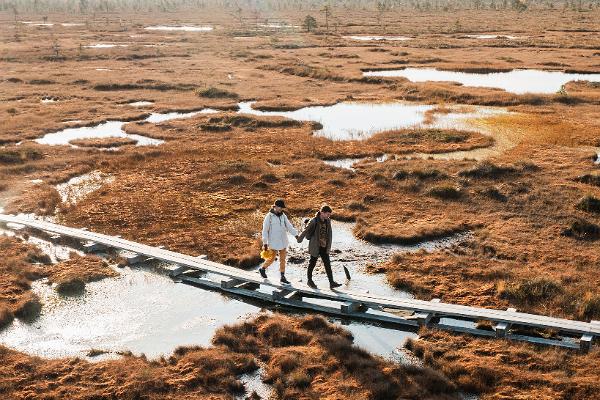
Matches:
[213,314,459,399]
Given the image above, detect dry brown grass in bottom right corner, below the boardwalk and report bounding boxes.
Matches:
[407,330,600,400]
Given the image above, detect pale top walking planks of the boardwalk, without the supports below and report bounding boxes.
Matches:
[0,215,600,344]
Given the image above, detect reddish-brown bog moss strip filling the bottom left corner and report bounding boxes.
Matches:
[0,347,257,400]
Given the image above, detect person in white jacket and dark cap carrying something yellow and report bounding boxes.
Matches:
[258,199,298,284]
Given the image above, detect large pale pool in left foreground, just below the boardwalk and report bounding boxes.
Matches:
[0,268,260,358]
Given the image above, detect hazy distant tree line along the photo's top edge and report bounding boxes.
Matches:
[0,0,600,14]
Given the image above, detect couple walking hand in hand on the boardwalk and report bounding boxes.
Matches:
[258,199,342,289]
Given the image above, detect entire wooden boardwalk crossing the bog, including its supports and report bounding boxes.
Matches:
[0,214,600,351]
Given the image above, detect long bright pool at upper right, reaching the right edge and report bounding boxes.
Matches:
[363,68,600,94]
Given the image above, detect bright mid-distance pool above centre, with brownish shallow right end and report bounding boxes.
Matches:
[238,102,506,140]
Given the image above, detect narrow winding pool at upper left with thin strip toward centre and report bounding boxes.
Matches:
[35,108,218,147]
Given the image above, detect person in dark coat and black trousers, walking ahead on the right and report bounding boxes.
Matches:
[297,205,342,289]
